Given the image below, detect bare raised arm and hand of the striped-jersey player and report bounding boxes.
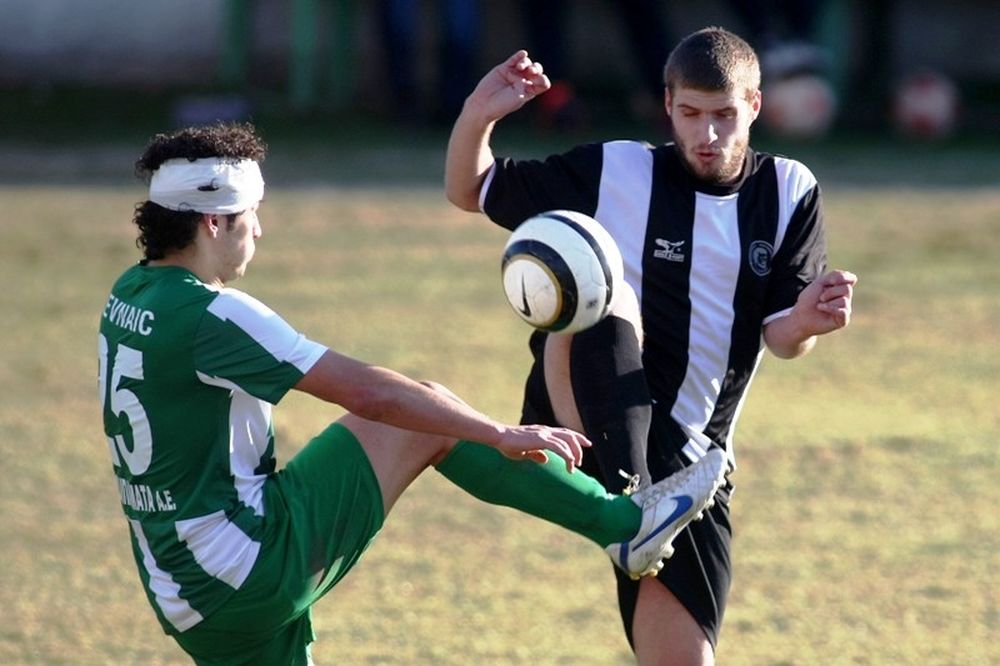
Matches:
[444,50,552,212]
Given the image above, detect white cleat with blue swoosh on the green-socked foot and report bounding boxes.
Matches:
[605,447,729,579]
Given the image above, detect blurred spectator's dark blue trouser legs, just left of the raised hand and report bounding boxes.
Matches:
[379,0,480,124]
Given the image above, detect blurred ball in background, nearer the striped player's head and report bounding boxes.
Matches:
[761,74,837,139]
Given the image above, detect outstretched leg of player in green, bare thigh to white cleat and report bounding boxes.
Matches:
[340,378,725,576]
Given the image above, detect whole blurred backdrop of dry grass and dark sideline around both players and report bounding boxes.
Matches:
[0,0,1000,666]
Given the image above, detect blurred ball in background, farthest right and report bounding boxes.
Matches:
[892,71,959,139]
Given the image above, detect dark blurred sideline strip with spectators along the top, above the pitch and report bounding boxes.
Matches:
[0,0,1000,147]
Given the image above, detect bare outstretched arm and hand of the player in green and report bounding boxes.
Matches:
[295,350,589,469]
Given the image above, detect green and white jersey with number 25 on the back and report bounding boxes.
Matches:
[98,264,326,634]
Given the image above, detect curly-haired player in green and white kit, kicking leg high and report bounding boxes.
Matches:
[98,124,726,664]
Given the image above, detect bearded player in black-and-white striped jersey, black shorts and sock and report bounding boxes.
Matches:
[445,28,856,664]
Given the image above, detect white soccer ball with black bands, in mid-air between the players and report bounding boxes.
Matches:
[500,210,625,333]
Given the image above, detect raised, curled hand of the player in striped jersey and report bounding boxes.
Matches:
[466,49,552,122]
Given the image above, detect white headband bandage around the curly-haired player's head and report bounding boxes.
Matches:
[149,157,264,214]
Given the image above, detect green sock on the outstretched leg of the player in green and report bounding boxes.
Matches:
[437,441,642,548]
